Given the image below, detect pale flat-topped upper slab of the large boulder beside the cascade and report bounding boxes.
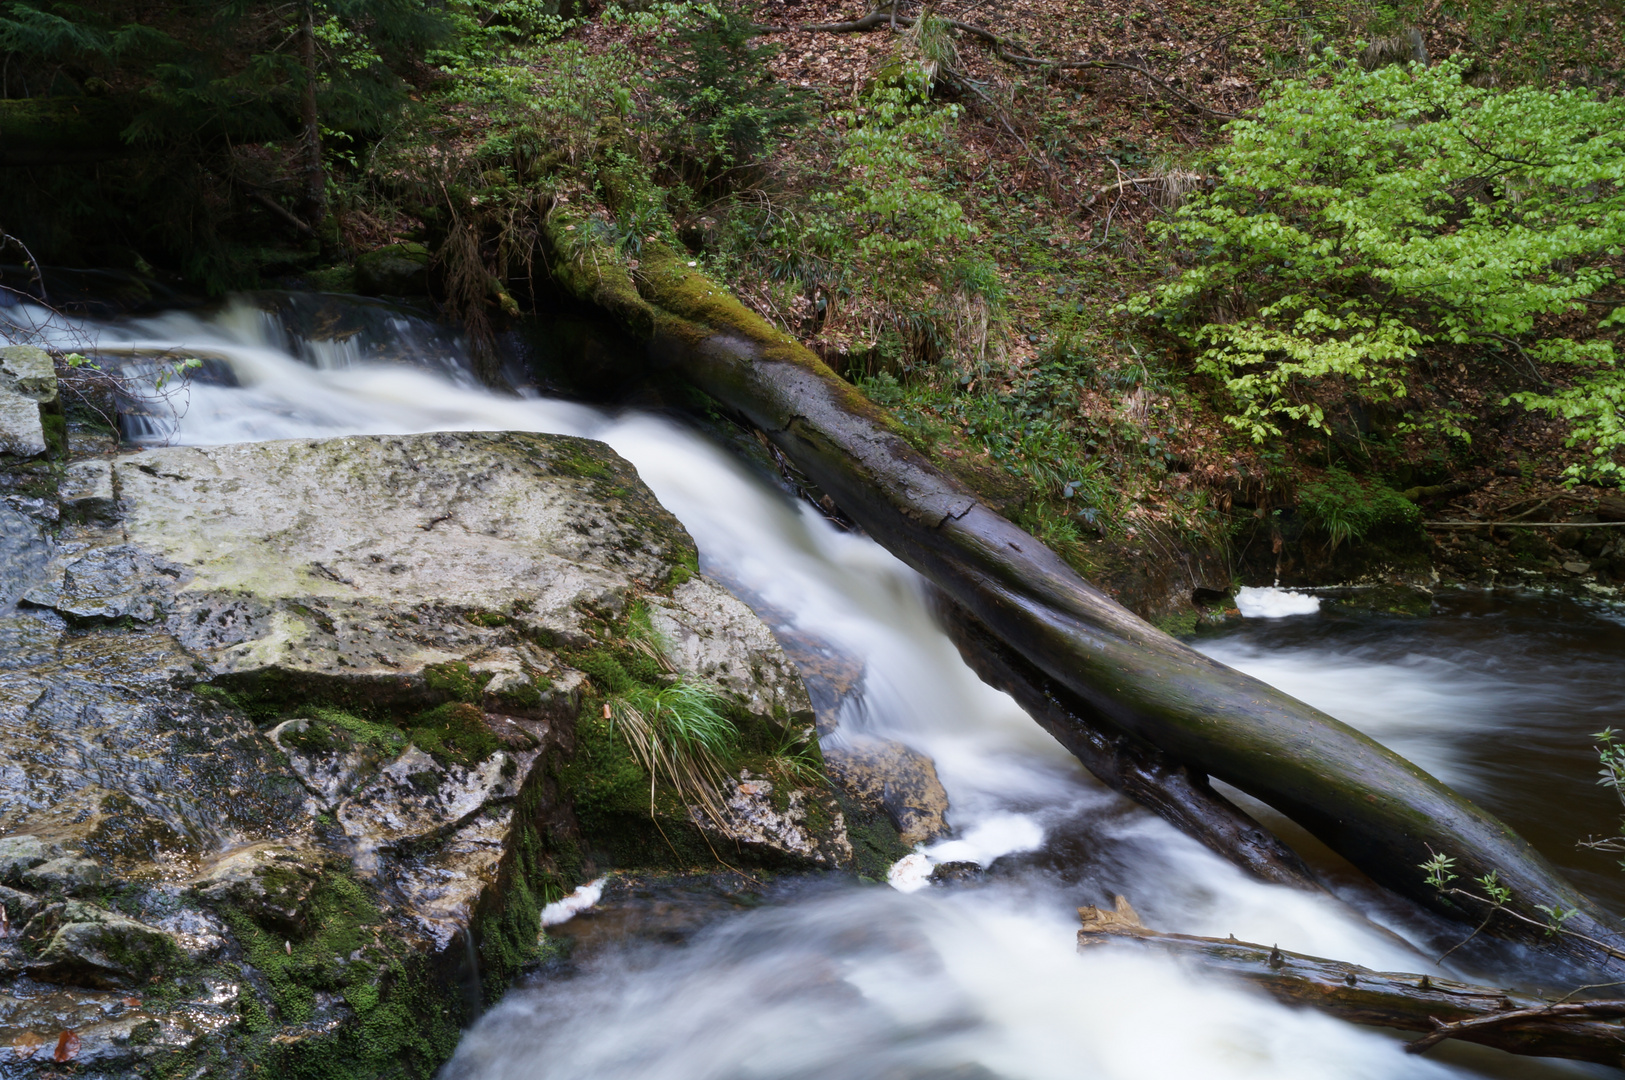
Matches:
[93,434,691,682]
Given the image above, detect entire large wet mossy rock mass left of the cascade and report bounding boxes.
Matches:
[0,434,852,1077]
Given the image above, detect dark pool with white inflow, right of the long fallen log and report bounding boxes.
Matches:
[1194,591,1625,911]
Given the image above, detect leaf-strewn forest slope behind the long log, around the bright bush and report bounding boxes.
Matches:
[539,0,1625,616]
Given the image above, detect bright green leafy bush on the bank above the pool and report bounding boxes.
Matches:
[1129,55,1625,473]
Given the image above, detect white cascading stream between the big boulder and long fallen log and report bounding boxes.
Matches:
[19,298,1599,1080]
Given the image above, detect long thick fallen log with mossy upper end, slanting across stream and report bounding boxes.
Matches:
[543,206,1625,971]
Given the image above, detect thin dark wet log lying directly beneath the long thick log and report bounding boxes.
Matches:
[938,596,1320,890]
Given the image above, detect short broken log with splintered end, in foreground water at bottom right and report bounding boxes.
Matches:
[1077,896,1625,1067]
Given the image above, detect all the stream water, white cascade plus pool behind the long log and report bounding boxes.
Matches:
[11,295,1625,1080]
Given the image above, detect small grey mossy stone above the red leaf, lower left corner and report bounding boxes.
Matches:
[23,900,180,989]
